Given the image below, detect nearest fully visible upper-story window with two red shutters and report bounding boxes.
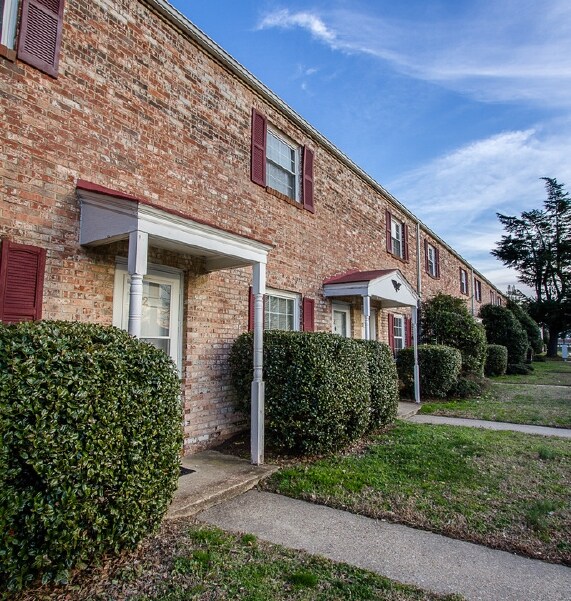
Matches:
[251,109,315,213]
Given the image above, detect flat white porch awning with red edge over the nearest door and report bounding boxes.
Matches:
[77,180,272,271]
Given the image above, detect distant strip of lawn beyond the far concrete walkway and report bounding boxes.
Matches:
[419,384,571,428]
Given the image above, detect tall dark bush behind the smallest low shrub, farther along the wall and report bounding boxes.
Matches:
[480,305,529,363]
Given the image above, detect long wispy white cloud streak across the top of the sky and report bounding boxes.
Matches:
[258,0,571,107]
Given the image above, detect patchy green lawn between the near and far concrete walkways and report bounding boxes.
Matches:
[265,422,571,564]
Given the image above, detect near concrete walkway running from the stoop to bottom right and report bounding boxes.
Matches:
[197,490,571,601]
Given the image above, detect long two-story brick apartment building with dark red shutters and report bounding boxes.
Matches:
[0,0,502,451]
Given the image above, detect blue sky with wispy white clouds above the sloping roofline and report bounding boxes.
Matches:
[171,0,571,290]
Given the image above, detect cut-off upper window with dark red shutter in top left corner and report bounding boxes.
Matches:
[0,0,64,77]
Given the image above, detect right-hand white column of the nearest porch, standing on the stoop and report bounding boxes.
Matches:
[250,263,266,465]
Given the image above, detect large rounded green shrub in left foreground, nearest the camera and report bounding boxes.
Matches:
[0,321,182,591]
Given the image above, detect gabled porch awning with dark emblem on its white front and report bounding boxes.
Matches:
[323,269,419,308]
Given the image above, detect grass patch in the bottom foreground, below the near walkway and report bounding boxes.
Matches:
[13,520,463,601]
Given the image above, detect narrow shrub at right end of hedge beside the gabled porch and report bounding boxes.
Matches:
[357,340,399,428]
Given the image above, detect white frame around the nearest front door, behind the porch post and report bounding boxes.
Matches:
[113,257,183,373]
